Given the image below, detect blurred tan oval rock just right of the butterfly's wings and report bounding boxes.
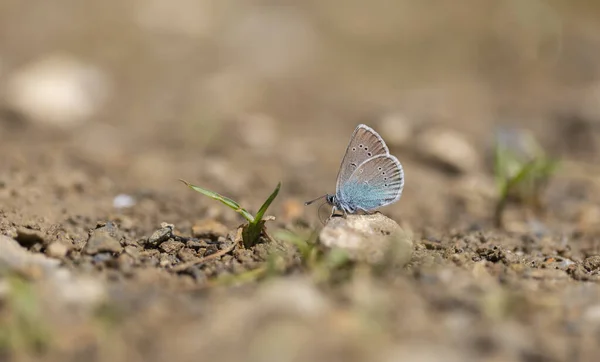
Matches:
[415,127,480,173]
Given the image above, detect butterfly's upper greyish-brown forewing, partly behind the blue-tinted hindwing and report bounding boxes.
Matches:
[335,124,390,192]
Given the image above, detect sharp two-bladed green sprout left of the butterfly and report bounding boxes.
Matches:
[179,180,281,248]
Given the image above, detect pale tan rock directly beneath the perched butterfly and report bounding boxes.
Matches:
[319,213,413,266]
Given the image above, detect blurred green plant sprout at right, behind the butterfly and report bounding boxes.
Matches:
[494,130,558,227]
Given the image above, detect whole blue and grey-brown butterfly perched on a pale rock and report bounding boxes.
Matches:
[305,124,404,216]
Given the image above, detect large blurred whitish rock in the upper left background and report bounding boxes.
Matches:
[4,55,108,127]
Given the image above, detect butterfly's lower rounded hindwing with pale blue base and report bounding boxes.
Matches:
[337,155,404,211]
